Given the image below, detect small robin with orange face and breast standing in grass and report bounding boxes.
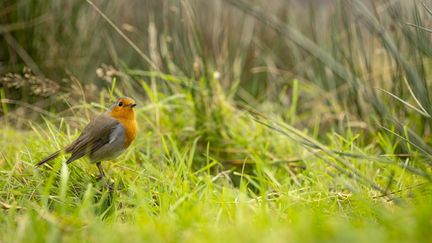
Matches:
[36,97,138,179]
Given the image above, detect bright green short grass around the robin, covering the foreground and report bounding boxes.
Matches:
[0,78,432,242]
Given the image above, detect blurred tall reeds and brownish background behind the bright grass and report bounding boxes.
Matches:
[0,0,432,151]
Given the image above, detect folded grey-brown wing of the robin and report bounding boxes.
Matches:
[65,114,119,163]
